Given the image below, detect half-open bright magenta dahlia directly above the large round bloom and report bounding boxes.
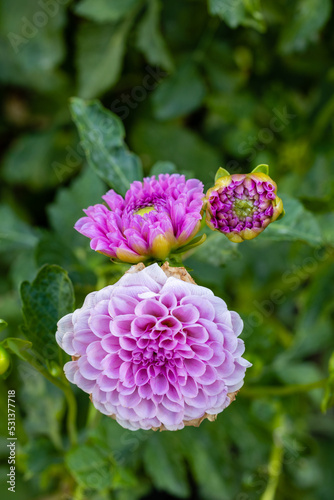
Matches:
[75,174,204,263]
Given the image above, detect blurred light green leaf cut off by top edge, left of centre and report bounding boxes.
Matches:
[74,0,138,23]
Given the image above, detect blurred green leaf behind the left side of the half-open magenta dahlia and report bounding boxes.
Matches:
[47,167,105,248]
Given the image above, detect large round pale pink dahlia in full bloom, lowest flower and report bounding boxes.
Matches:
[56,263,250,430]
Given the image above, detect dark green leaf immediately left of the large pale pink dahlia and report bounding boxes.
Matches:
[21,265,74,365]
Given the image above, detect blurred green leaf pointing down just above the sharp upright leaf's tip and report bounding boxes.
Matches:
[76,17,133,99]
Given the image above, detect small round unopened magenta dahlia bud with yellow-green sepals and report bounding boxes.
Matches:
[206,165,284,243]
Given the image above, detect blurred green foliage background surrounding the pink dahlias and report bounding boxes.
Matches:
[0,0,334,500]
